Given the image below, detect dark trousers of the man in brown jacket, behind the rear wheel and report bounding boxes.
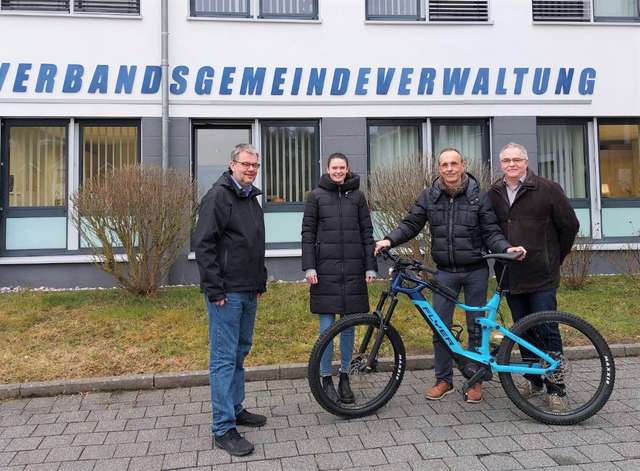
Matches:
[507,289,564,393]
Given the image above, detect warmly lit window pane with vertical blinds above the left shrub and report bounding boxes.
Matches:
[80,122,140,184]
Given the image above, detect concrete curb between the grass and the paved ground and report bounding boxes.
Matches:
[0,344,640,400]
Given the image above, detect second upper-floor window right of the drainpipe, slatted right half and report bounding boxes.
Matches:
[366,0,489,22]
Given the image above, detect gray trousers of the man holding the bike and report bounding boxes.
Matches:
[433,268,489,383]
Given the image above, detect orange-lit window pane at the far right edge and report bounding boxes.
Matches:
[598,120,640,199]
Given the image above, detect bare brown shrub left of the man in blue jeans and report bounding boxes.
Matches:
[72,166,198,296]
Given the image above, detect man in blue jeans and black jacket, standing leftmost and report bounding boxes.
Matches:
[194,144,267,456]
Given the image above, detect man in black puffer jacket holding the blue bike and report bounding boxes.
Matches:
[376,148,526,402]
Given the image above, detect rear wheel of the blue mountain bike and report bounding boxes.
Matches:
[497,311,615,425]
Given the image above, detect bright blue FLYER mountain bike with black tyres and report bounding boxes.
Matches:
[308,252,615,425]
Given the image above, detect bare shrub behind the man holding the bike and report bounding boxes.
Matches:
[368,155,491,265]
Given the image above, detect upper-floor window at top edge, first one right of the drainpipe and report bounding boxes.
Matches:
[191,0,318,20]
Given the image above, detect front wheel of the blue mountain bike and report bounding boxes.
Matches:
[308,314,406,418]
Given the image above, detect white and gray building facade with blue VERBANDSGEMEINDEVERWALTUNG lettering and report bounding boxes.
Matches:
[0,0,640,286]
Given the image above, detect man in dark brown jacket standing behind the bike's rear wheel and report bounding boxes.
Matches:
[489,143,579,411]
